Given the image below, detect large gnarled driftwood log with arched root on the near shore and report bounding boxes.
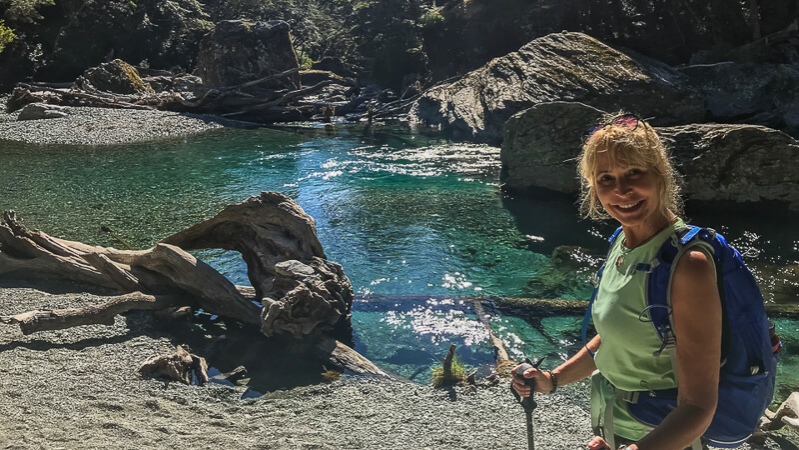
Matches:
[0,192,389,377]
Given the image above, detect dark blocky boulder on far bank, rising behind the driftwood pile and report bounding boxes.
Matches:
[197,20,300,88]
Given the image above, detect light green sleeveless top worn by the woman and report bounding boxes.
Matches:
[592,220,685,440]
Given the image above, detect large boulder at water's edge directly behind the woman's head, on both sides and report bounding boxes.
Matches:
[500,102,799,210]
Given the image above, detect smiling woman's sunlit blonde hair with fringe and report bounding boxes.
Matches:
[577,111,682,220]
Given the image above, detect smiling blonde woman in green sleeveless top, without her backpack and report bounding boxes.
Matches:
[513,114,722,450]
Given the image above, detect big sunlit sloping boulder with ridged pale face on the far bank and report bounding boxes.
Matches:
[411,33,704,144]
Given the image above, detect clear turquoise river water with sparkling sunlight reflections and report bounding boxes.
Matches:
[0,122,799,398]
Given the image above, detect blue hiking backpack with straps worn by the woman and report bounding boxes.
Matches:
[583,226,782,448]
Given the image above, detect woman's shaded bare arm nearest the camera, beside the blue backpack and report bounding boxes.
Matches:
[629,250,722,450]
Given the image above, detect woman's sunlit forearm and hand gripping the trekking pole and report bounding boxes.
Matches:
[513,335,601,397]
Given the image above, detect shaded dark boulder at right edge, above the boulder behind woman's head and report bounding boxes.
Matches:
[678,62,799,137]
